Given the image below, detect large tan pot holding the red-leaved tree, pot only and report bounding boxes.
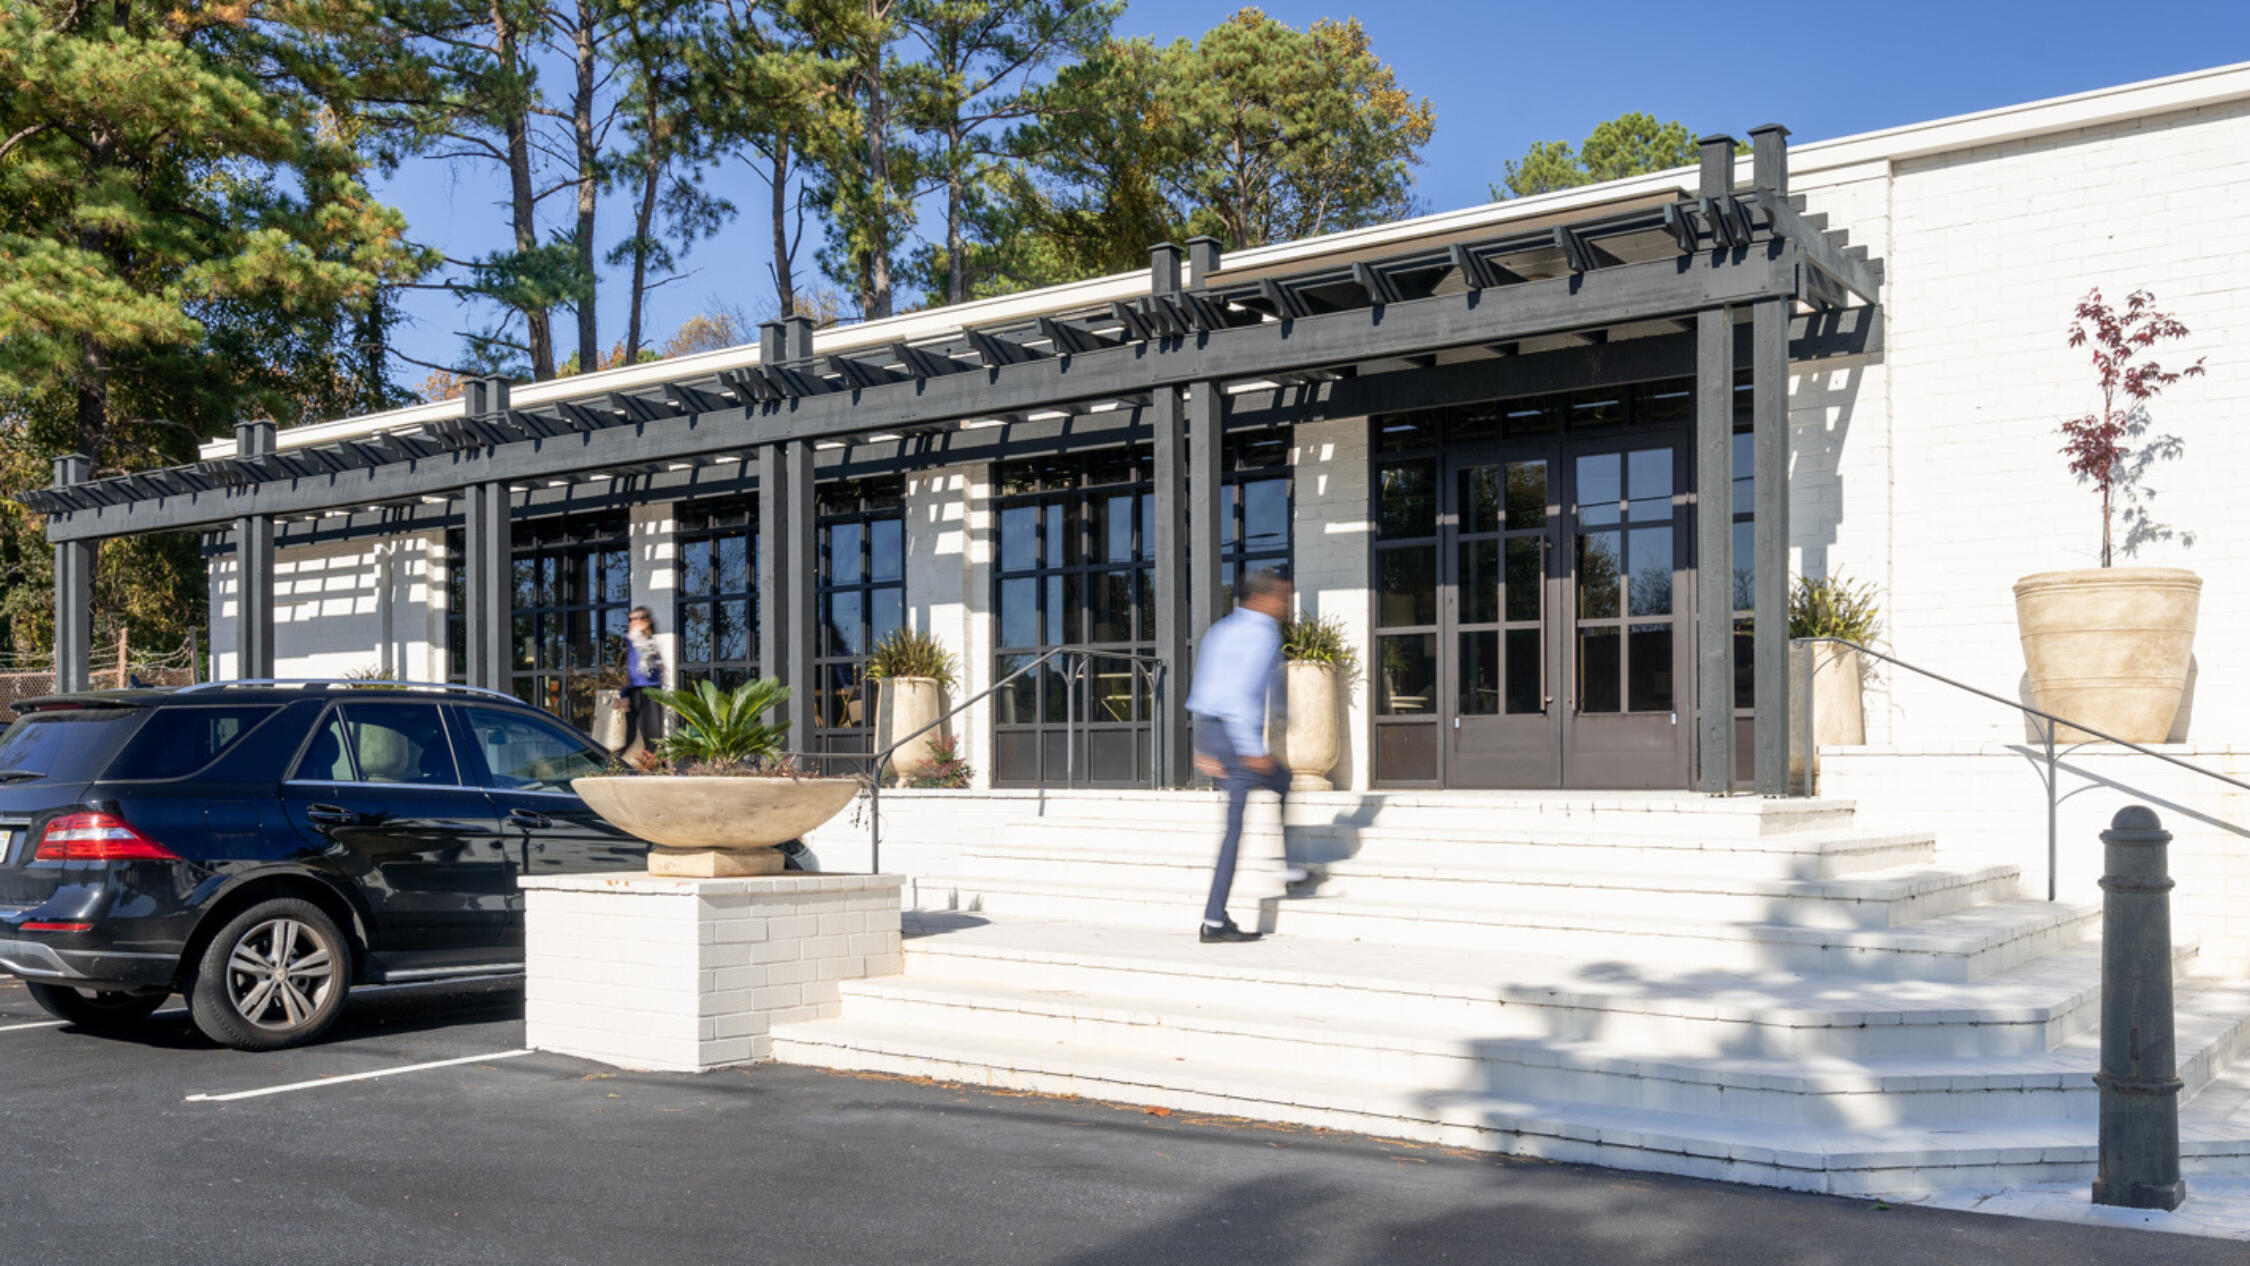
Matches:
[2016,567,2203,742]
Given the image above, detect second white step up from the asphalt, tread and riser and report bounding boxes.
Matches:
[819,976,2250,1129]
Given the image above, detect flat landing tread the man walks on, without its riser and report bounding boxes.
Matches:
[905,911,2194,1025]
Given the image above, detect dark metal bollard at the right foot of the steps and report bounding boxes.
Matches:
[2095,805,2187,1210]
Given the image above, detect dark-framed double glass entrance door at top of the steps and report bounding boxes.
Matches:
[1438,436,1692,787]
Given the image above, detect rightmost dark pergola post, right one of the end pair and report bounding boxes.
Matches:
[1751,124,1791,796]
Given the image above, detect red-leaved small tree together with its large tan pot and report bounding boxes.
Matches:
[2016,290,2203,742]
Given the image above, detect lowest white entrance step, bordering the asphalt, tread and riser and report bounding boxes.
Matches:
[774,1014,2250,1194]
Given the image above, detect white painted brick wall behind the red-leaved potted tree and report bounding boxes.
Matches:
[1796,103,2250,744]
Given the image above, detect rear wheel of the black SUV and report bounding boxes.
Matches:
[187,897,351,1050]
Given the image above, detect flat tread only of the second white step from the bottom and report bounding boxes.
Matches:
[844,976,2250,1093]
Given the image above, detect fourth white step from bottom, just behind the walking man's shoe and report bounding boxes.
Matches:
[916,875,2102,980]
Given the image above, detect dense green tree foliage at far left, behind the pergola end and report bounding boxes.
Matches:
[0,0,432,648]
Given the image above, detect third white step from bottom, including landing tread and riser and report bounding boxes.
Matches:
[902,915,2196,1059]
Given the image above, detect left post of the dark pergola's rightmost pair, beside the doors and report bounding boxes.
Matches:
[1694,135,1735,796]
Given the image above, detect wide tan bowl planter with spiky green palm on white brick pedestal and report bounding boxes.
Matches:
[572,679,860,879]
